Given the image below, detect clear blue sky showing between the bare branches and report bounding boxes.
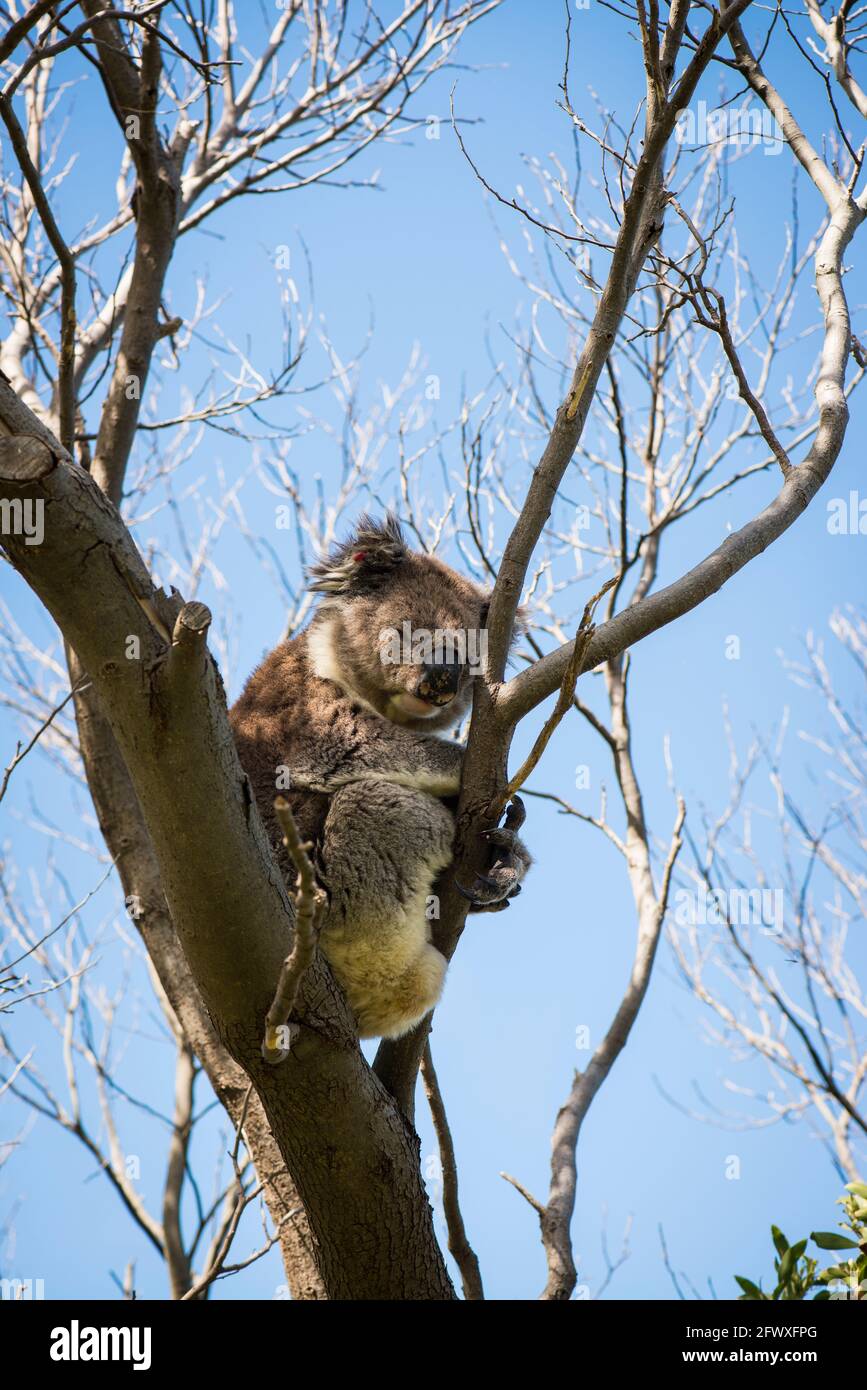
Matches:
[0,0,864,1298]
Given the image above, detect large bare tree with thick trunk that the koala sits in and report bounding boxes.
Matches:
[0,0,867,1300]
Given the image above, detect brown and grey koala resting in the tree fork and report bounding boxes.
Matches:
[229,514,531,1038]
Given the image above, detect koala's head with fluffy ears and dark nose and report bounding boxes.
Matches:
[307,514,488,730]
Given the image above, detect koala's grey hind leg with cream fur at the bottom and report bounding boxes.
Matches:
[320,777,454,1037]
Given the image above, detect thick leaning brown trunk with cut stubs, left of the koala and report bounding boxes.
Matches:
[0,411,454,1300]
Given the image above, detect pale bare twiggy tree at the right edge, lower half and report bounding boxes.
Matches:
[670,610,867,1183]
